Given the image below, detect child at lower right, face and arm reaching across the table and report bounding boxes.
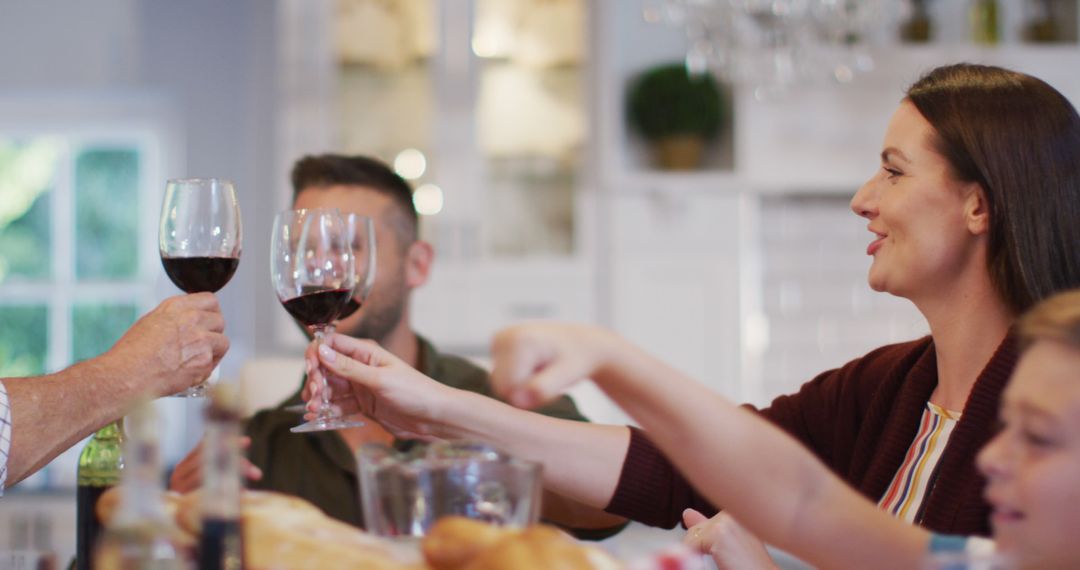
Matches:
[464,290,1080,569]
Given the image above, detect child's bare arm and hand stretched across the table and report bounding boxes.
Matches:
[492,324,929,568]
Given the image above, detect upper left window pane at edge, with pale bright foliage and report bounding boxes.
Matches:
[0,139,60,283]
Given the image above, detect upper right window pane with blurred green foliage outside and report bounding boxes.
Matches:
[75,148,139,280]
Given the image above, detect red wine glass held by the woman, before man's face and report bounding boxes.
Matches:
[270,208,364,433]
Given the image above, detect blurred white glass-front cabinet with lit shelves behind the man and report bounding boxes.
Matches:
[279,0,595,353]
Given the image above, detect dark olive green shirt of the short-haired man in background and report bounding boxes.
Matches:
[245,338,588,527]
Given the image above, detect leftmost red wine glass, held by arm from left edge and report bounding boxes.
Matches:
[158,178,241,397]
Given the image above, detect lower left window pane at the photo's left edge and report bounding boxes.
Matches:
[0,304,49,378]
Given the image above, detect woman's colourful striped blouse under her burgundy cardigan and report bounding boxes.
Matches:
[878,402,960,523]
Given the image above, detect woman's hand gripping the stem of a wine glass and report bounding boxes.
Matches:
[303,335,460,439]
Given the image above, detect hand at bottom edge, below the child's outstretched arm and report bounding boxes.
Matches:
[683,508,777,570]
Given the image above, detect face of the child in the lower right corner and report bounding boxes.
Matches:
[978,340,1080,568]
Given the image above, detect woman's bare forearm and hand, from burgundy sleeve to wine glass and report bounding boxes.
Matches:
[306,335,630,509]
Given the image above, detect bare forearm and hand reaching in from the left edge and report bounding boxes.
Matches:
[3,293,229,486]
